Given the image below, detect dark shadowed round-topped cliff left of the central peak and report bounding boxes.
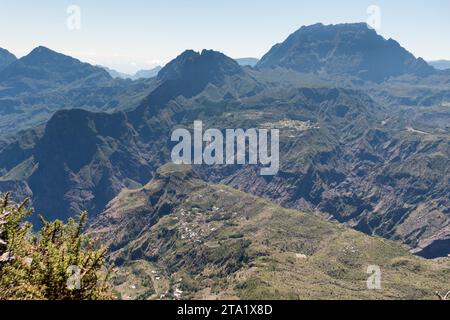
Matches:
[27,109,162,220]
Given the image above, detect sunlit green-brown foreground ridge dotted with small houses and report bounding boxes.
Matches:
[90,165,450,299]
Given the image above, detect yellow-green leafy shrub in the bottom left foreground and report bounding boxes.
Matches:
[0,195,113,300]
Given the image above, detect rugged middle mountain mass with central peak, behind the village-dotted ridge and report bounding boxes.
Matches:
[0,42,450,258]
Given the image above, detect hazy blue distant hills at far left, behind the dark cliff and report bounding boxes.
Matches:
[0,47,158,134]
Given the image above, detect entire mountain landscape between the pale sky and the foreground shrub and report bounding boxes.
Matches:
[0,24,450,298]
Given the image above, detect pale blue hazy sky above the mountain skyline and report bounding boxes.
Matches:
[0,0,450,72]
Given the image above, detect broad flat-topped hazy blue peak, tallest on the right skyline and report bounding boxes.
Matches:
[257,23,434,82]
